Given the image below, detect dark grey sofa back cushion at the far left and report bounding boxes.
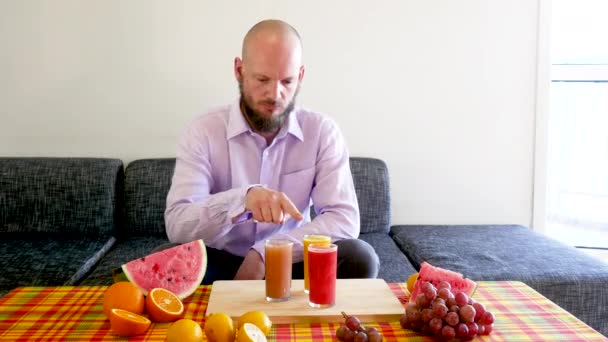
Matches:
[0,158,123,236]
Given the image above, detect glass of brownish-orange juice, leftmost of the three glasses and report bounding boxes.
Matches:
[264,240,293,302]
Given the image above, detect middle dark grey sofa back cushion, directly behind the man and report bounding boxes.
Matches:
[124,157,390,236]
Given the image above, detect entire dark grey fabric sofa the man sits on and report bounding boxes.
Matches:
[0,157,608,336]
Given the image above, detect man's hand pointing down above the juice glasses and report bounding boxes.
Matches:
[245,186,304,224]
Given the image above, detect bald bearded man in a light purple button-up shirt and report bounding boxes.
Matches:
[165,20,379,284]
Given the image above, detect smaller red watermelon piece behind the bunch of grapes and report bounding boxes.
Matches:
[410,261,477,301]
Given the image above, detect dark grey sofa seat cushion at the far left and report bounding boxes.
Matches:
[0,233,115,292]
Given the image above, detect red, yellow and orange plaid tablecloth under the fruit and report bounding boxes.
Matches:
[0,281,608,342]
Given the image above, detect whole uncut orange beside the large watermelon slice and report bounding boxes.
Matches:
[103,281,144,317]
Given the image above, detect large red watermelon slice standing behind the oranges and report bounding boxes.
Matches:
[112,240,207,299]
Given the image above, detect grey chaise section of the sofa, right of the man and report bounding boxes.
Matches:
[391,225,608,336]
